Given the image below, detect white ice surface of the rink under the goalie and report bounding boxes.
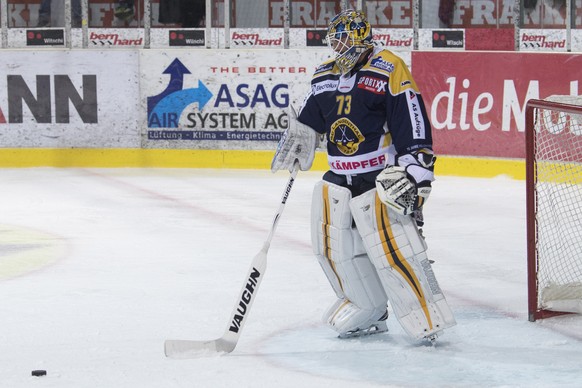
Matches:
[0,168,582,388]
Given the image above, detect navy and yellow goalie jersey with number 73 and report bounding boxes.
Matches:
[298,48,432,175]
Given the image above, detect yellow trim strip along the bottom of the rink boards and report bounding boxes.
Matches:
[0,148,525,180]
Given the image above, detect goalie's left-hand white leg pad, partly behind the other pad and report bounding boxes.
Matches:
[311,181,388,336]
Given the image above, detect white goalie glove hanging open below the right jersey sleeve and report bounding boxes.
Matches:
[376,151,436,215]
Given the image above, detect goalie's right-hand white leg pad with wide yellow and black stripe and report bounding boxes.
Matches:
[350,189,456,339]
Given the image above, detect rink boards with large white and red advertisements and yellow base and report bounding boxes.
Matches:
[0,49,582,178]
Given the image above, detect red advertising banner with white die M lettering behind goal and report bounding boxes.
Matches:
[412,52,582,158]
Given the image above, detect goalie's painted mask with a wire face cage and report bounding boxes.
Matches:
[326,9,373,74]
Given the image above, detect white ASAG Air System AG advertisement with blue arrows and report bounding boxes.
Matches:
[140,49,329,149]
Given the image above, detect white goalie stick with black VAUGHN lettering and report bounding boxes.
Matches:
[164,160,299,359]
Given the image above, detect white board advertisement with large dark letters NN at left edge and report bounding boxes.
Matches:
[0,50,139,148]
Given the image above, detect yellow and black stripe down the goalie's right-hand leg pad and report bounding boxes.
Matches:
[375,195,433,330]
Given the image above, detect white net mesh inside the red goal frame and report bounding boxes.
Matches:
[534,96,582,313]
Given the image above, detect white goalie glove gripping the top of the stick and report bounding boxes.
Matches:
[271,106,319,172]
